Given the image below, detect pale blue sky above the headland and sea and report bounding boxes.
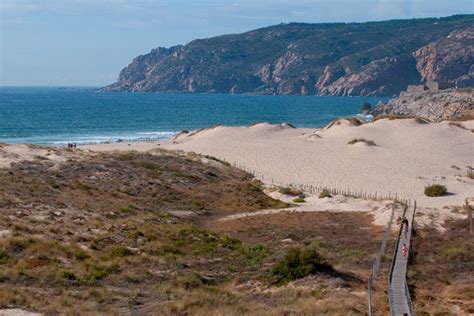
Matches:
[0,0,474,86]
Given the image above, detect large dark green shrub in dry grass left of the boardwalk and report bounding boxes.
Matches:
[272,248,332,284]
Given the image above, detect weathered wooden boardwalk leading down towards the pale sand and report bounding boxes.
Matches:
[389,203,416,316]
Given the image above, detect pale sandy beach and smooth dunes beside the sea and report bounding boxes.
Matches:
[81,119,474,209]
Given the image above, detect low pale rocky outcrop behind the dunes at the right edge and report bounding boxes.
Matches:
[371,88,474,122]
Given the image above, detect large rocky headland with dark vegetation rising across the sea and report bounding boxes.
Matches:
[102,15,474,96]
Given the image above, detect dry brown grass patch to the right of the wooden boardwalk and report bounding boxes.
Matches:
[409,220,474,315]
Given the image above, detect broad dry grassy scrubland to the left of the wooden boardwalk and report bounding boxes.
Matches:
[0,149,382,315]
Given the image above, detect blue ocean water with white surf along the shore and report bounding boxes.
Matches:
[0,87,386,145]
